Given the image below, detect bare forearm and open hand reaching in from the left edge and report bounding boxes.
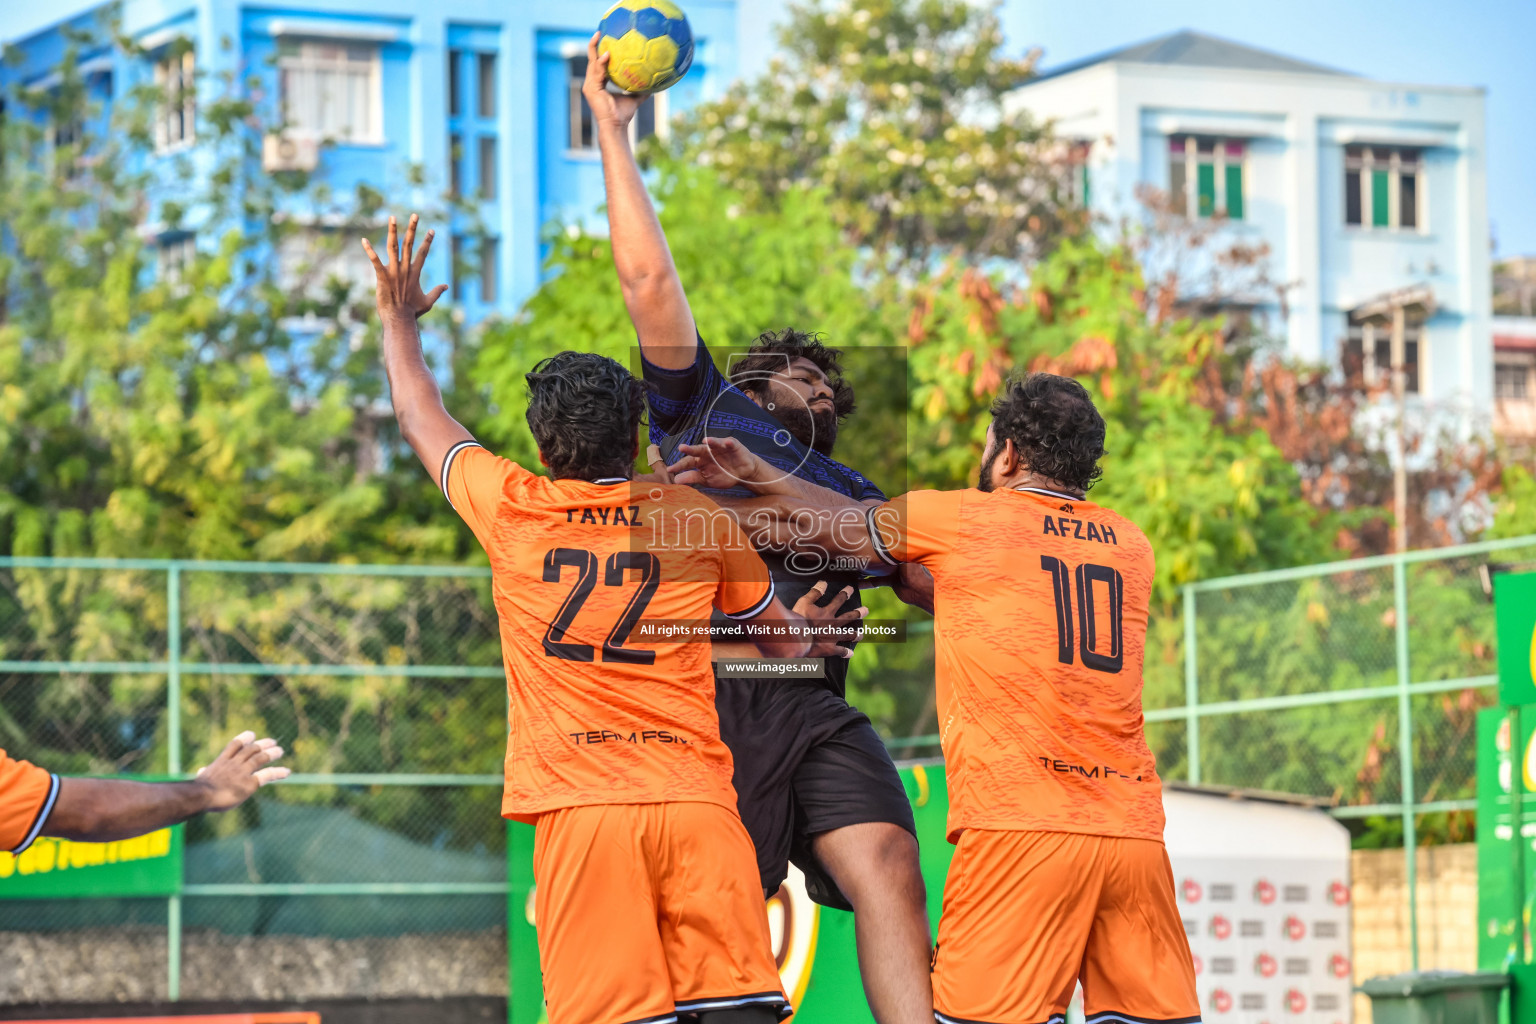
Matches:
[43,732,289,843]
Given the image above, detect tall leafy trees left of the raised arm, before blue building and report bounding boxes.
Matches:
[0,28,505,844]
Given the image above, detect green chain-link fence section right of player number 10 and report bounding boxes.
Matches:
[1146,537,1536,969]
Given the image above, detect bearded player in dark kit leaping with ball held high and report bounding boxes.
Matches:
[582,37,932,1024]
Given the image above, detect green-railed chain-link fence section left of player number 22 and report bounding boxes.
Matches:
[0,559,507,999]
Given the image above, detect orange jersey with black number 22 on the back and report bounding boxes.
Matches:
[442,442,774,821]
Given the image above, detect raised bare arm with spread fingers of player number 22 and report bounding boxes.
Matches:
[362,213,475,479]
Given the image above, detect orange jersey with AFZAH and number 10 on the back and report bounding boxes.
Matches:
[869,490,1163,841]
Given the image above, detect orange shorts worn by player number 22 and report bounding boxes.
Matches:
[533,803,790,1024]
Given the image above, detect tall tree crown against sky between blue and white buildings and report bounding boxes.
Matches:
[671,0,1081,266]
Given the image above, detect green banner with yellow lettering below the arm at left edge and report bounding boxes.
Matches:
[0,824,183,900]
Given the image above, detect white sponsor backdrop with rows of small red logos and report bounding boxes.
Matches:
[1163,791,1353,1024]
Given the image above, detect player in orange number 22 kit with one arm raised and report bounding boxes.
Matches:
[362,216,857,1024]
